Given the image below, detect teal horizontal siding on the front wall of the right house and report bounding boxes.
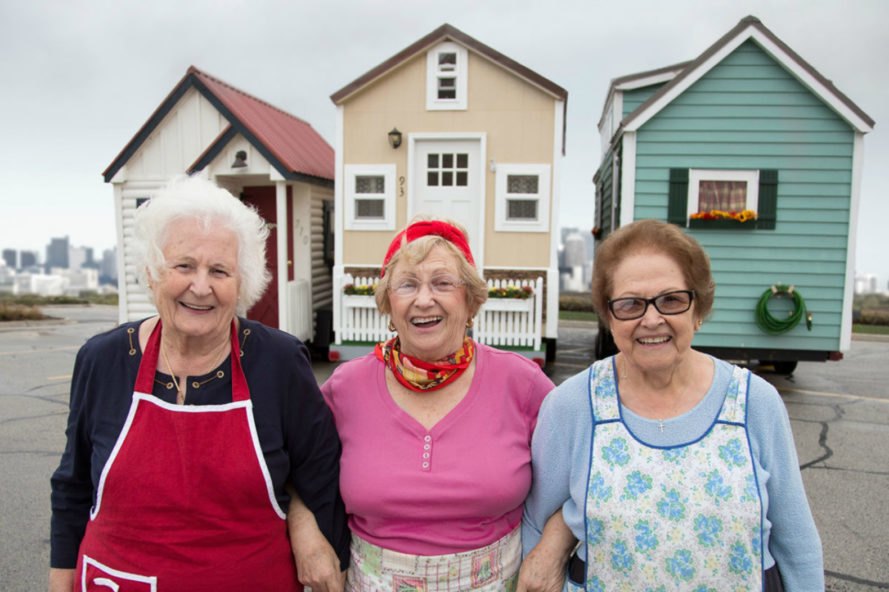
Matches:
[625,41,854,351]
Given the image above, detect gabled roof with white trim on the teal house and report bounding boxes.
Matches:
[605,16,874,134]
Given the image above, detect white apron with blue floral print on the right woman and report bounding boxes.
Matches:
[569,359,763,592]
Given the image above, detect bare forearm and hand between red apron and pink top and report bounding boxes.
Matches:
[287,490,346,592]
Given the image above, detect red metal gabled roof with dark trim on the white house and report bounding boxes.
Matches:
[102,66,334,183]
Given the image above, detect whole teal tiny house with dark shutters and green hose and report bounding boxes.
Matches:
[593,17,874,371]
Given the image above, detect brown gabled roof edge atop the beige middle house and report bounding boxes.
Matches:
[330,23,568,105]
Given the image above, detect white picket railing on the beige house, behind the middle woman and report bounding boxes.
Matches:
[336,274,543,350]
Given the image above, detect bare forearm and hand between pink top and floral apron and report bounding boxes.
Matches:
[516,510,577,592]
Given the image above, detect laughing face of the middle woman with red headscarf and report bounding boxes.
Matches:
[388,246,469,362]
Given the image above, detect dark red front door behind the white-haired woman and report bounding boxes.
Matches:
[241,187,293,328]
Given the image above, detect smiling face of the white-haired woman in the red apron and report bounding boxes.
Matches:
[151,219,241,343]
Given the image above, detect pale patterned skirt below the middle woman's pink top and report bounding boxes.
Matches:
[346,528,522,592]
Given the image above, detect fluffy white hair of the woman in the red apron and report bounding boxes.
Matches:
[133,176,271,314]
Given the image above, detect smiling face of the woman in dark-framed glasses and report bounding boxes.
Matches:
[609,251,697,372]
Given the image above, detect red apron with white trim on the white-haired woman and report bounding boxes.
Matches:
[74,321,302,592]
